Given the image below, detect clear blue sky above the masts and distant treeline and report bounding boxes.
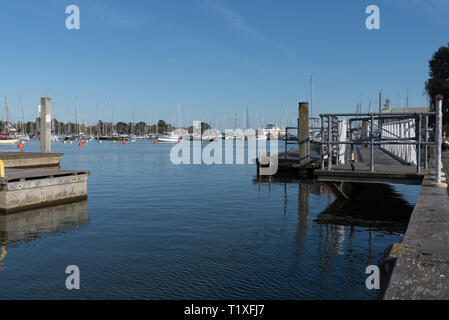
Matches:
[0,0,449,128]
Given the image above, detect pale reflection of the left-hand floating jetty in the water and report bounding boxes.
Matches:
[0,201,89,270]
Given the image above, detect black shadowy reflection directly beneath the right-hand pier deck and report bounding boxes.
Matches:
[253,177,413,234]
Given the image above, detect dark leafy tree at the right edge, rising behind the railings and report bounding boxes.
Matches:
[426,44,449,124]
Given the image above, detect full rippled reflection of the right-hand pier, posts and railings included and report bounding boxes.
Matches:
[253,177,413,291]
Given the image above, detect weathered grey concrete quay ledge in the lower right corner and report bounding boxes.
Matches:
[380,156,449,300]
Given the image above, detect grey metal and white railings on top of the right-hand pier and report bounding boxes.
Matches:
[320,98,442,184]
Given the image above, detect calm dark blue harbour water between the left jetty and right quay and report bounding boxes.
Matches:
[0,142,419,299]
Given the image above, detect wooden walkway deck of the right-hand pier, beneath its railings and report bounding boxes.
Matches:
[314,148,428,185]
